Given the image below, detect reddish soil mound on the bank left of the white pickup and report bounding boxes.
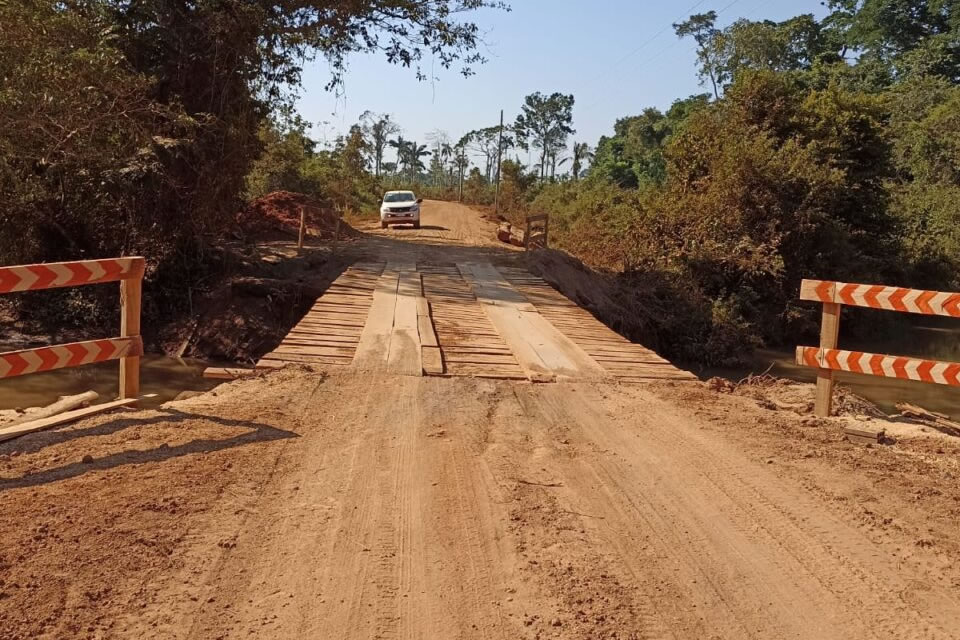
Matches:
[237,191,357,238]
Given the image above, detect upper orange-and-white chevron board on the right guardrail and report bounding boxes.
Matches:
[800,280,960,318]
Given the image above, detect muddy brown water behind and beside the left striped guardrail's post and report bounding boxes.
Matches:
[0,349,219,409]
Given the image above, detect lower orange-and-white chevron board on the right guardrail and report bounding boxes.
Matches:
[797,347,960,387]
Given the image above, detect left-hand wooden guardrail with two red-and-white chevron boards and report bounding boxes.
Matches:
[0,257,146,399]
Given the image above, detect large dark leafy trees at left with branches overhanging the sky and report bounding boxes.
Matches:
[0,0,505,330]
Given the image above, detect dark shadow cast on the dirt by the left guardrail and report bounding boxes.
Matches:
[0,409,299,493]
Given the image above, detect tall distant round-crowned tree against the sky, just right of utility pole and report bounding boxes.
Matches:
[513,91,576,181]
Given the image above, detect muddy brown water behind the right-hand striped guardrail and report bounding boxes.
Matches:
[737,322,960,420]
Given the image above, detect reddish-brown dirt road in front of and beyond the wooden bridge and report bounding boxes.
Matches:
[0,206,960,640]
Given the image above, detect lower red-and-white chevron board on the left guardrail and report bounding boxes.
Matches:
[0,336,143,378]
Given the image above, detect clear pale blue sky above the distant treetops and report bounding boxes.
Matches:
[298,0,825,162]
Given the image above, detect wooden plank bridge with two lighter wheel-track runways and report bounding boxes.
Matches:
[257,262,696,382]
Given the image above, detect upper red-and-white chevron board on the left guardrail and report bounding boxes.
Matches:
[0,257,144,293]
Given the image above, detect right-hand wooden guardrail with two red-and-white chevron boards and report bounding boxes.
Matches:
[797,280,960,417]
